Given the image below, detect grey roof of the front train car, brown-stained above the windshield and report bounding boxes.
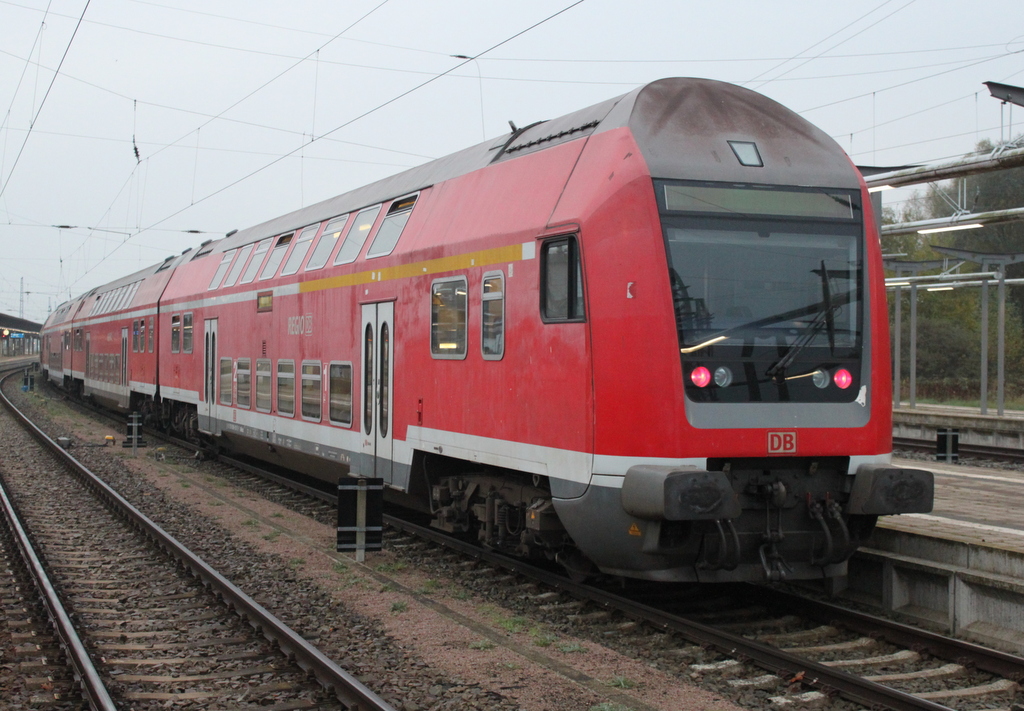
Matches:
[201,78,859,252]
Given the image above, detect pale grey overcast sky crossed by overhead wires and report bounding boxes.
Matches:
[0,0,1024,322]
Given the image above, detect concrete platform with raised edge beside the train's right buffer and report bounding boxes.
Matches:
[843,460,1024,655]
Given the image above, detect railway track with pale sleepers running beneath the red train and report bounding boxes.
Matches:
[19,381,1024,711]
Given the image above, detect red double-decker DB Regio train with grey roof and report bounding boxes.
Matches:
[42,79,932,581]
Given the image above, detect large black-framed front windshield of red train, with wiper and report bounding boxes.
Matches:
[658,182,864,401]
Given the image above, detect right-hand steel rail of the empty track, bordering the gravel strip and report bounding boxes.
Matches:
[0,376,395,711]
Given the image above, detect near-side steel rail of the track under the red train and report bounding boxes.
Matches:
[385,516,950,711]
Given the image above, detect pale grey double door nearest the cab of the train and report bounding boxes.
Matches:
[362,301,394,484]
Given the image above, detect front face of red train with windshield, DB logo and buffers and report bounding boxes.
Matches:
[563,180,933,582]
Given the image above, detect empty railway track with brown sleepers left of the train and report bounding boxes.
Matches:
[0,372,392,711]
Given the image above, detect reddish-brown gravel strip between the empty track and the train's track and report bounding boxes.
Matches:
[17,385,739,711]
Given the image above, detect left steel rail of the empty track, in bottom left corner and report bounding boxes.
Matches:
[0,471,117,711]
